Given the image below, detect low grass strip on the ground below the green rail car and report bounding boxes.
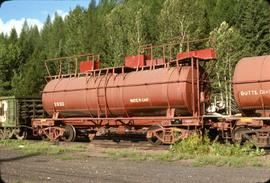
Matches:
[0,139,86,155]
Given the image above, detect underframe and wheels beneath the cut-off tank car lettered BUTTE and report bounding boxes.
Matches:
[211,117,270,148]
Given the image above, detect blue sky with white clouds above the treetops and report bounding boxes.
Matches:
[0,0,90,35]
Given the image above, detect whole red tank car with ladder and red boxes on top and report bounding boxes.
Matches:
[32,39,215,144]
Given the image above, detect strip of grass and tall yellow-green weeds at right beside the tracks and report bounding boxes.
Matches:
[104,135,270,167]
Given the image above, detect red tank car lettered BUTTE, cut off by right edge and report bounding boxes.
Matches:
[214,55,270,147]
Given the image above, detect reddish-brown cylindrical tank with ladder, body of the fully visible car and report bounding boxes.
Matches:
[42,66,197,117]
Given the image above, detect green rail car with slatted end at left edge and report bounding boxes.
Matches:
[0,96,45,139]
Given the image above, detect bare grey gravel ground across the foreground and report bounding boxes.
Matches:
[0,147,270,183]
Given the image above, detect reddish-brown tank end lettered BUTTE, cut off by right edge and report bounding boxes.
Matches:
[233,55,270,113]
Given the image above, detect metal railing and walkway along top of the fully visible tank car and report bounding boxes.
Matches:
[45,37,214,81]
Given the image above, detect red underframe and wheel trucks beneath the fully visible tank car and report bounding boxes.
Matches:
[32,117,203,144]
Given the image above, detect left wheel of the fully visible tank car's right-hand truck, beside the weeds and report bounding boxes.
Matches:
[147,125,163,145]
